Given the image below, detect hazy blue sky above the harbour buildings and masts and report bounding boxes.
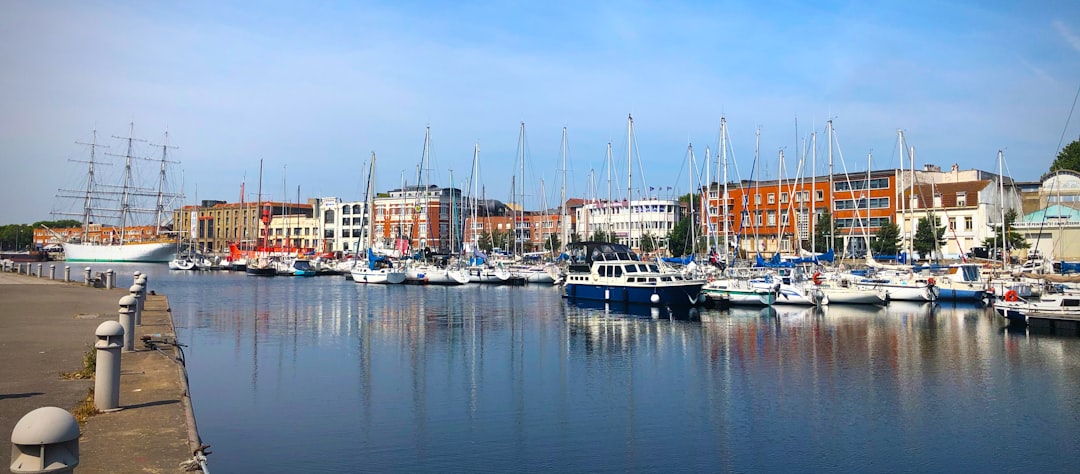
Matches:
[0,0,1080,225]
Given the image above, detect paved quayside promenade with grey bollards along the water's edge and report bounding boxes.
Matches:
[0,268,198,473]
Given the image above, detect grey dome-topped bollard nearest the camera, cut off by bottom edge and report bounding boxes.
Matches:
[10,407,79,473]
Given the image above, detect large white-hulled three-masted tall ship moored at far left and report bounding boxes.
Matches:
[54,123,178,262]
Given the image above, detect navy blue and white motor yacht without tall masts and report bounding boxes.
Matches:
[564,242,705,306]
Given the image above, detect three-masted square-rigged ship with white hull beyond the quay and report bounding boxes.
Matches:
[53,123,181,262]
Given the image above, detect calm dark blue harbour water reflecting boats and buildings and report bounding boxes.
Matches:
[105,266,1080,473]
